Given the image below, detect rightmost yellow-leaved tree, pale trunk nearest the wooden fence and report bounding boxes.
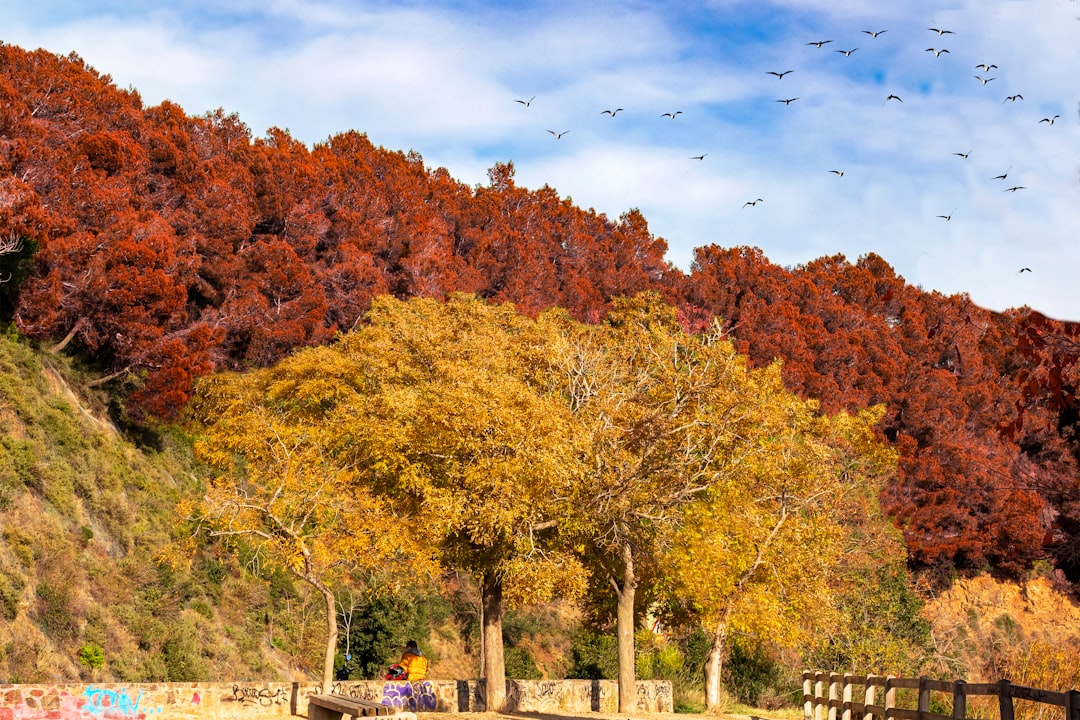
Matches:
[663,395,895,711]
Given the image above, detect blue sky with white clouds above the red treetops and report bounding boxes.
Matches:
[0,0,1080,321]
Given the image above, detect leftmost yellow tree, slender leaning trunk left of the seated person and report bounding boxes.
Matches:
[191,348,433,688]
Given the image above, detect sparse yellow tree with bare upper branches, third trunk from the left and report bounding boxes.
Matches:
[553,294,758,712]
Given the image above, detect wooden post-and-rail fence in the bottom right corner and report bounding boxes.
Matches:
[802,671,1080,720]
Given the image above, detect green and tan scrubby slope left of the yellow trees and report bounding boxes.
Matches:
[0,337,295,682]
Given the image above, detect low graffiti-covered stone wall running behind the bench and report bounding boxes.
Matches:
[0,680,672,720]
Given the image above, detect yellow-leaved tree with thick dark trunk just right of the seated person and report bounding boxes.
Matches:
[338,295,585,710]
